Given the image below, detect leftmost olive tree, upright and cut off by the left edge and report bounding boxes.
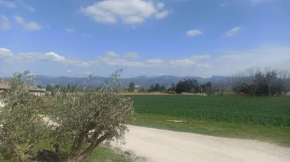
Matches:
[0,72,49,162]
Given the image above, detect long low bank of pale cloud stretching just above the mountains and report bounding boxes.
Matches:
[0,45,290,77]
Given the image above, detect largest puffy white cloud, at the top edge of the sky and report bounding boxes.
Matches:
[81,0,168,24]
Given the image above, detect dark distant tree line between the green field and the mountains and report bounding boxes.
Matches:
[46,68,290,97]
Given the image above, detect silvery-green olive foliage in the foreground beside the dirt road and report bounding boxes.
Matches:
[0,71,133,162]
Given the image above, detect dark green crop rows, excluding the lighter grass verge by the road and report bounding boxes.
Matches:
[130,95,290,127]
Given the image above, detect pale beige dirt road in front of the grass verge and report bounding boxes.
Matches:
[114,126,290,162]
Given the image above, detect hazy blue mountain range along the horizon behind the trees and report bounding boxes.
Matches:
[1,75,227,88]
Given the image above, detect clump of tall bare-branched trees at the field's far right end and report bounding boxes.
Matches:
[229,68,290,97]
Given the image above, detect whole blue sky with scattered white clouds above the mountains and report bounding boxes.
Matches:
[0,0,290,77]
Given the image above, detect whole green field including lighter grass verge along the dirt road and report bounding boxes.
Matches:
[130,95,290,146]
